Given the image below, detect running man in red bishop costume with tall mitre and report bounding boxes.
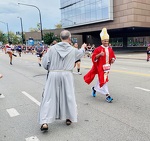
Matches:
[84,28,116,103]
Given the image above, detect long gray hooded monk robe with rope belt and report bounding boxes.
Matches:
[39,42,85,124]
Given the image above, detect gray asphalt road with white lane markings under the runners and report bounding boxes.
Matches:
[0,52,150,141]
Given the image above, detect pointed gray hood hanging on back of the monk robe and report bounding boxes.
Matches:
[54,42,73,58]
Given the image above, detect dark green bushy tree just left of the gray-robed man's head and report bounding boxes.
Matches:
[43,32,60,45]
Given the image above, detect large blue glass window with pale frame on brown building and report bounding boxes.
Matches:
[61,0,113,27]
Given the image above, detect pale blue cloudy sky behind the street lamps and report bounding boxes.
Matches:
[0,0,61,33]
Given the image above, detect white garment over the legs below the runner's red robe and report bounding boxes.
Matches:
[94,80,109,95]
